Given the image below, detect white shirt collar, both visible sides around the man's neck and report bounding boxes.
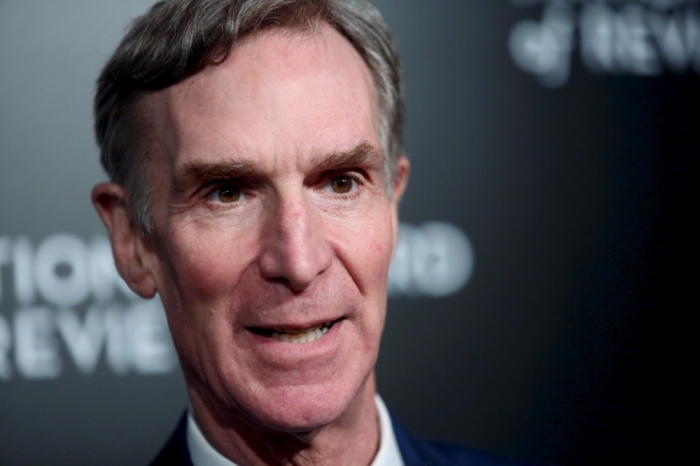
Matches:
[187,395,404,466]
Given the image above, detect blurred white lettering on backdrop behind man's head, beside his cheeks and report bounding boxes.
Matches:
[0,222,474,381]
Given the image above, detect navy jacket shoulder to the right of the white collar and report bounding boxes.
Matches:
[391,419,531,466]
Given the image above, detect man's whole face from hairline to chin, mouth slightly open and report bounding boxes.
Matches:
[136,27,406,430]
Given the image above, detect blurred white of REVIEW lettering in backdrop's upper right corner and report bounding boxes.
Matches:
[509,0,700,87]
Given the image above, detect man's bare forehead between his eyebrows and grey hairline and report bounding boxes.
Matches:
[145,25,378,169]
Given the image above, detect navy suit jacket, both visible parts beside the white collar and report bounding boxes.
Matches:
[151,415,530,466]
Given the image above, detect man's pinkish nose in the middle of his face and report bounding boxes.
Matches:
[259,194,332,291]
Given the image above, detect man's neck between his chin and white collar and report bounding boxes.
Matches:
[190,373,379,466]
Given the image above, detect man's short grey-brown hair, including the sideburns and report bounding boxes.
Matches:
[94,0,403,233]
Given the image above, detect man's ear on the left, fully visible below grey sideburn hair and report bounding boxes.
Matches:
[92,183,157,299]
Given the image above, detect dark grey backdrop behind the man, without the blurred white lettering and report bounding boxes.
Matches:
[0,0,700,465]
